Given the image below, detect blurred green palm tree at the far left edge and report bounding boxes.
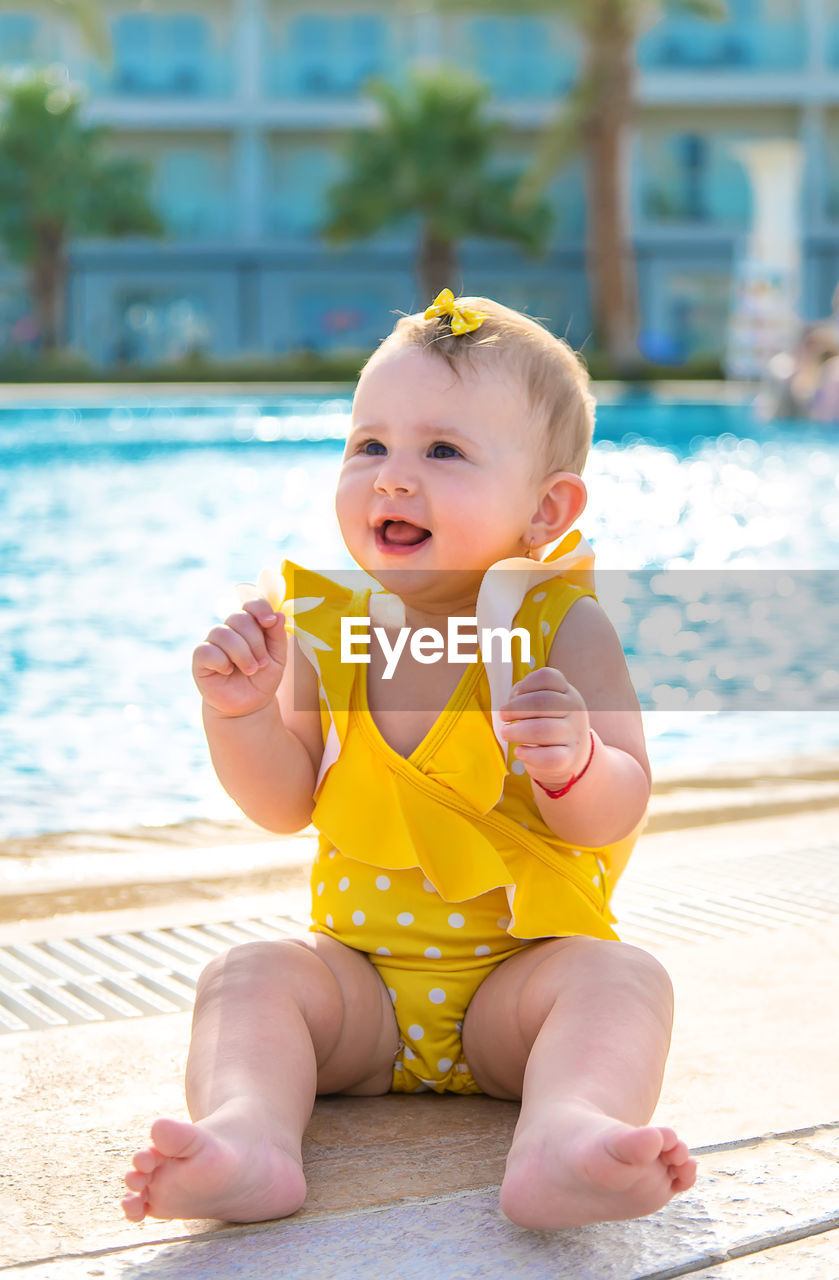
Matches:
[0,72,161,352]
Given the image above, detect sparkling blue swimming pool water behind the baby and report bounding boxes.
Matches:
[0,396,839,837]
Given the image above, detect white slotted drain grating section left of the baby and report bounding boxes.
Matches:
[0,916,300,1034]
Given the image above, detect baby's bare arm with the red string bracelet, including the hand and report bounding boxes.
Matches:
[501,596,649,847]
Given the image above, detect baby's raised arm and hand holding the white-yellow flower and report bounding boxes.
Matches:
[192,600,323,833]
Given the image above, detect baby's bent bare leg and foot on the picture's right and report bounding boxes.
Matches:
[464,937,696,1229]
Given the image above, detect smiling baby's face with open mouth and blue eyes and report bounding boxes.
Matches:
[336,347,550,609]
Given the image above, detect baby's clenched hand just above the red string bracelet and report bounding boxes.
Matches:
[500,667,591,791]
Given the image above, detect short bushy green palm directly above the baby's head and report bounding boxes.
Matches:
[324,68,552,298]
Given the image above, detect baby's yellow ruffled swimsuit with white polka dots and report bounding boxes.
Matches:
[272,535,637,1093]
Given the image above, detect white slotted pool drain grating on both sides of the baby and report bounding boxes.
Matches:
[0,845,839,1034]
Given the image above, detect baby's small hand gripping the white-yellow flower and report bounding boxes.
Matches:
[192,599,288,716]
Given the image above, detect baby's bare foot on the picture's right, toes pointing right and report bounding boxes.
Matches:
[501,1105,697,1230]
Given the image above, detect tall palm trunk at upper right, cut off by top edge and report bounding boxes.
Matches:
[433,0,726,371]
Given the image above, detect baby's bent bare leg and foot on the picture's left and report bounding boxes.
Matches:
[123,936,398,1222]
